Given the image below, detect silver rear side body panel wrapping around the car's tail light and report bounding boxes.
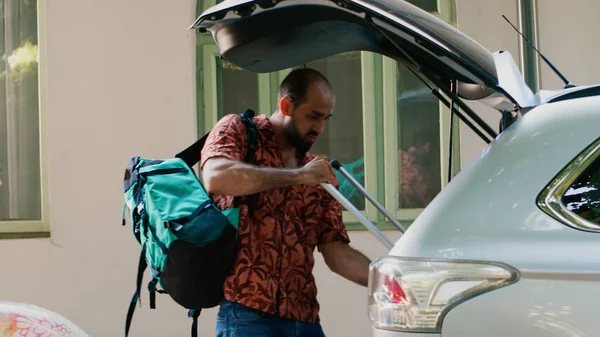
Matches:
[390,96,600,337]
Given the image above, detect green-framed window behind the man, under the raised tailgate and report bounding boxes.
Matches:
[198,0,460,229]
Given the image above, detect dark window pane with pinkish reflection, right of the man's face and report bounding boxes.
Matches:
[397,66,441,208]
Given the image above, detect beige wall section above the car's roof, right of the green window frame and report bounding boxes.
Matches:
[455,0,600,167]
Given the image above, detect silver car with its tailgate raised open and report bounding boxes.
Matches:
[192,0,600,337]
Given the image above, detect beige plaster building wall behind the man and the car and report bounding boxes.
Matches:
[0,0,600,337]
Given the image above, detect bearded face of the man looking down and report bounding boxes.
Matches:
[283,82,335,153]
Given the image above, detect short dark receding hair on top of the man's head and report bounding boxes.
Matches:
[278,68,333,106]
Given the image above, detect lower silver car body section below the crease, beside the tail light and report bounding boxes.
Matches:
[440,273,600,337]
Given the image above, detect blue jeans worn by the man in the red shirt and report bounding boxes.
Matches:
[216,299,325,337]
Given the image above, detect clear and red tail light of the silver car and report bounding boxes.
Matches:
[368,256,518,332]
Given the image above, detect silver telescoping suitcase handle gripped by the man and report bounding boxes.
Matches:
[321,159,406,249]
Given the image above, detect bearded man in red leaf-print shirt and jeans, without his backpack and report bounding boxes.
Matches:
[201,69,370,337]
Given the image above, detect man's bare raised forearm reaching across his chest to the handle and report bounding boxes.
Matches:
[204,159,302,196]
